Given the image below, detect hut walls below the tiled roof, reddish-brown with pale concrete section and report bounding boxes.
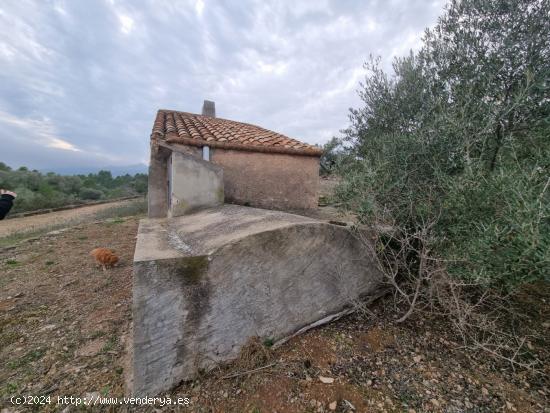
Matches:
[148,144,319,218]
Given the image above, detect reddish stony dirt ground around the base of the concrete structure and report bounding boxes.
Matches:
[0,217,550,413]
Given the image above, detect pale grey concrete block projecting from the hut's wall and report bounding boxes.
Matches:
[168,151,224,217]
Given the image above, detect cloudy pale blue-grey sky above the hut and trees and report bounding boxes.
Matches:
[0,0,444,169]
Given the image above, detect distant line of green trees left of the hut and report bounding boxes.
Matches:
[0,162,147,213]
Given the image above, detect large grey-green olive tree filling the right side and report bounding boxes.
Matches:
[337,0,550,290]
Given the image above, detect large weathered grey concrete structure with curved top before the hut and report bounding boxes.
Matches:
[133,205,381,396]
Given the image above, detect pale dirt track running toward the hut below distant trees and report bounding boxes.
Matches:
[0,199,144,236]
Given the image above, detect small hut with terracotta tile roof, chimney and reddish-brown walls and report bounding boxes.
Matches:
[149,101,322,218]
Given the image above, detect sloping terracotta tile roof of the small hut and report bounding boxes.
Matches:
[151,109,322,156]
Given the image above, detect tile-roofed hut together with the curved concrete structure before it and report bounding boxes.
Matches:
[132,102,384,397]
